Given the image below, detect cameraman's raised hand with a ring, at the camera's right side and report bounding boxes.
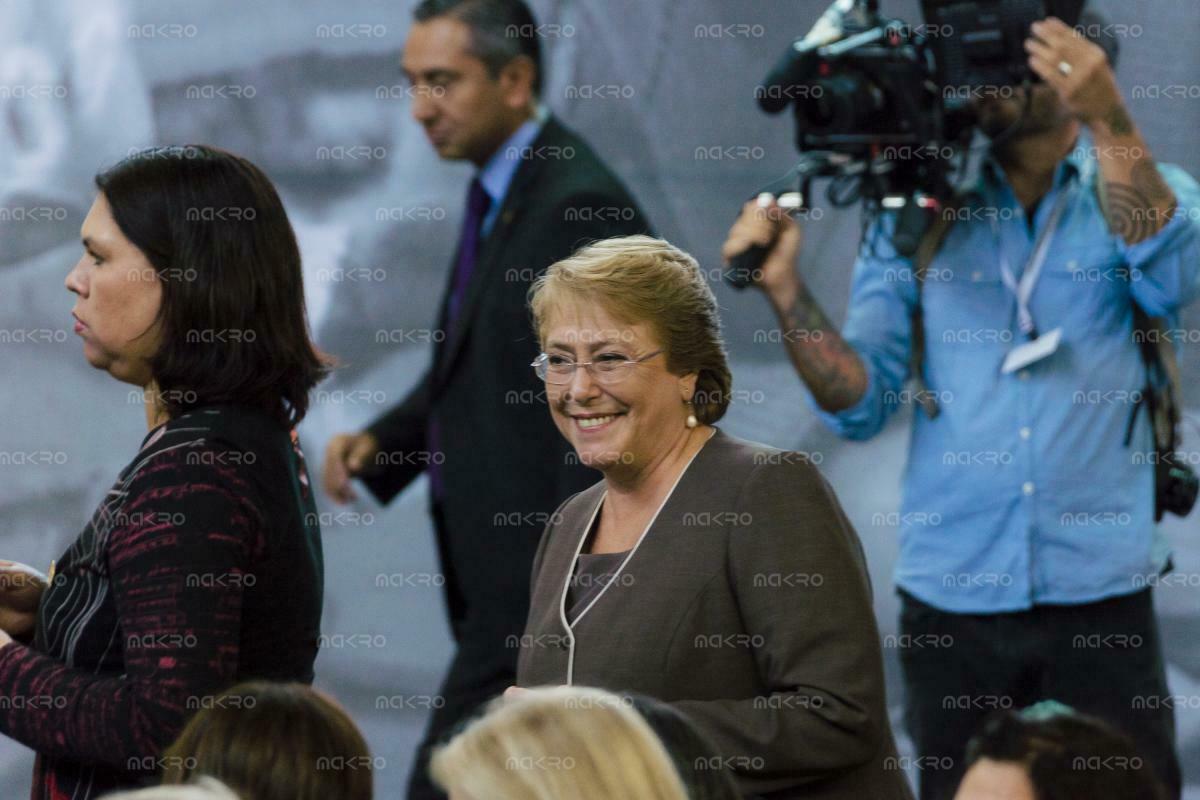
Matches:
[1025,17,1133,136]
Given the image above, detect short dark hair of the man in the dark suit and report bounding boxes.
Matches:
[413,0,541,95]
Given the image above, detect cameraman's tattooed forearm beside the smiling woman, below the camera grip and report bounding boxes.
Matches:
[779,287,866,411]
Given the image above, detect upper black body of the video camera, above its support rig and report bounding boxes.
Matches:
[756,0,1084,161]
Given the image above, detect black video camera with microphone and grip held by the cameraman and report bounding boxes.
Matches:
[725,0,1085,289]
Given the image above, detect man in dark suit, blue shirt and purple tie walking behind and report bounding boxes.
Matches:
[324,0,648,798]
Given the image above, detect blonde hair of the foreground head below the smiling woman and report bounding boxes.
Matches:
[430,686,688,800]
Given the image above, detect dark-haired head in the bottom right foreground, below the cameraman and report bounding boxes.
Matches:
[954,700,1166,800]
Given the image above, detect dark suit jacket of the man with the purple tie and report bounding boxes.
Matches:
[365,118,648,682]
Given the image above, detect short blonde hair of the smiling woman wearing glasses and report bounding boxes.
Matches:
[529,236,733,425]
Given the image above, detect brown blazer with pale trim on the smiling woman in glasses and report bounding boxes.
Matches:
[512,431,912,800]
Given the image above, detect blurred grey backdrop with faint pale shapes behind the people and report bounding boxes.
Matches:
[0,0,1200,798]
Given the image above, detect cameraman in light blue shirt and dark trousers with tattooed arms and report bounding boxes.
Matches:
[724,18,1200,800]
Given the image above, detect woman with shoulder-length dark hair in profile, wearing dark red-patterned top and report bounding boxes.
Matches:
[0,146,326,800]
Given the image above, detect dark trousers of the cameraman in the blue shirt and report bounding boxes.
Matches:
[900,589,1181,800]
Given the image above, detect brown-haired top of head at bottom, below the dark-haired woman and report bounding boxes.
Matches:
[162,681,373,800]
